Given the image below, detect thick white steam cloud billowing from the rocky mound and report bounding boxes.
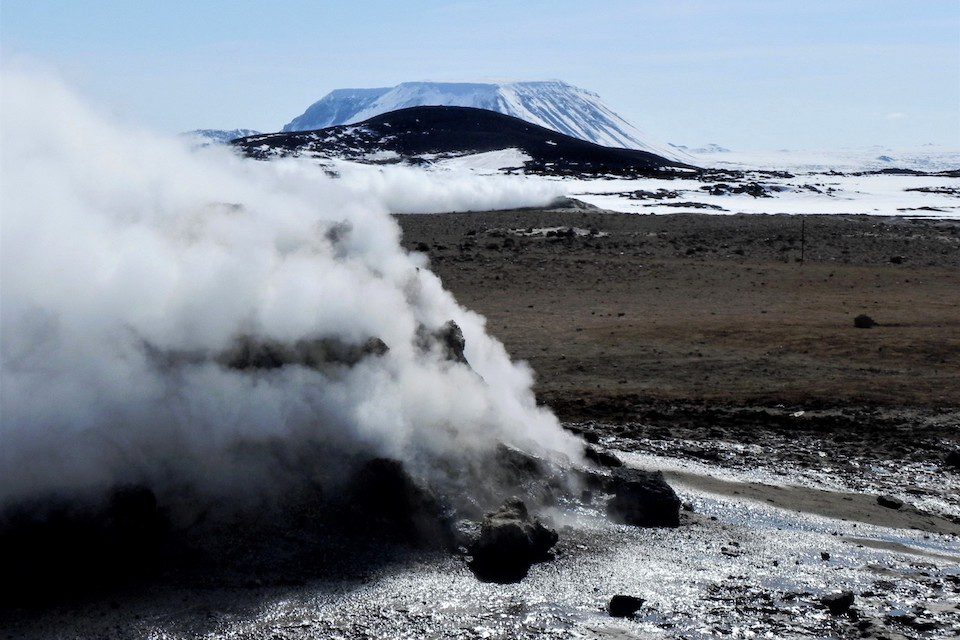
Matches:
[0,69,576,508]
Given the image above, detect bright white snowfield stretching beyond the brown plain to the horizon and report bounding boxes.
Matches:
[406,147,960,219]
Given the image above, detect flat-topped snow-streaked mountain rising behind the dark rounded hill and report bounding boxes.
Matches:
[283,81,691,162]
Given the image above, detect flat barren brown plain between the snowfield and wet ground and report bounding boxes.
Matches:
[397,206,960,414]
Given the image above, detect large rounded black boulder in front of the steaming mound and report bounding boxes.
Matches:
[469,498,558,583]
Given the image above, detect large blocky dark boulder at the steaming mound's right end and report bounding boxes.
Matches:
[607,468,680,527]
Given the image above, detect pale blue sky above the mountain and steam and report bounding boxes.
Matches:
[0,0,960,149]
